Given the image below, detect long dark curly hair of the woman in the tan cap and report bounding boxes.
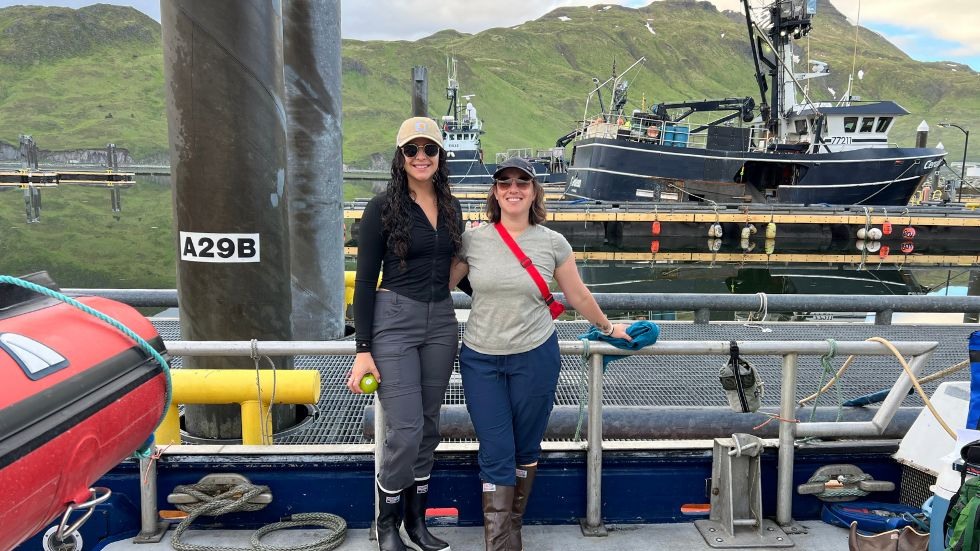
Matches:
[381,148,463,270]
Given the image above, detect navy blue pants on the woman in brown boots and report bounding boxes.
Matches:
[459,332,561,486]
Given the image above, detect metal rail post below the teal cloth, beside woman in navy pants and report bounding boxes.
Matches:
[580,352,608,536]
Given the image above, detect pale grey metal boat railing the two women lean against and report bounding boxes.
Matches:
[141,340,938,530]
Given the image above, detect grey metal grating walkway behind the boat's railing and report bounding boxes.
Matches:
[145,318,976,444]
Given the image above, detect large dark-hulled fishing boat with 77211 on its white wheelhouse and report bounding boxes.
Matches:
[557,0,946,205]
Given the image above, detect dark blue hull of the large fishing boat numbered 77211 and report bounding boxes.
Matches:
[565,138,946,205]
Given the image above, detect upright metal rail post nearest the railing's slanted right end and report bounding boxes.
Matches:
[776,352,799,526]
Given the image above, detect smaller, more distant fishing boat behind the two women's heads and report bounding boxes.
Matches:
[439,58,567,186]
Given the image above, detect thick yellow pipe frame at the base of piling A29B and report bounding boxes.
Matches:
[156,369,320,445]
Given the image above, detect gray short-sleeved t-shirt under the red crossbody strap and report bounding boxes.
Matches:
[462,224,572,355]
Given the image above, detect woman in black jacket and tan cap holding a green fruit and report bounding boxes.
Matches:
[347,117,463,551]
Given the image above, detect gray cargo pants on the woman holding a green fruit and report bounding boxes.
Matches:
[371,291,459,492]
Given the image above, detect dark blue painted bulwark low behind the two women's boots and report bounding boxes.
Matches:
[21,445,901,550]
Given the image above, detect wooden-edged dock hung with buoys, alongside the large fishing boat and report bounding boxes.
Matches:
[344,200,980,268]
